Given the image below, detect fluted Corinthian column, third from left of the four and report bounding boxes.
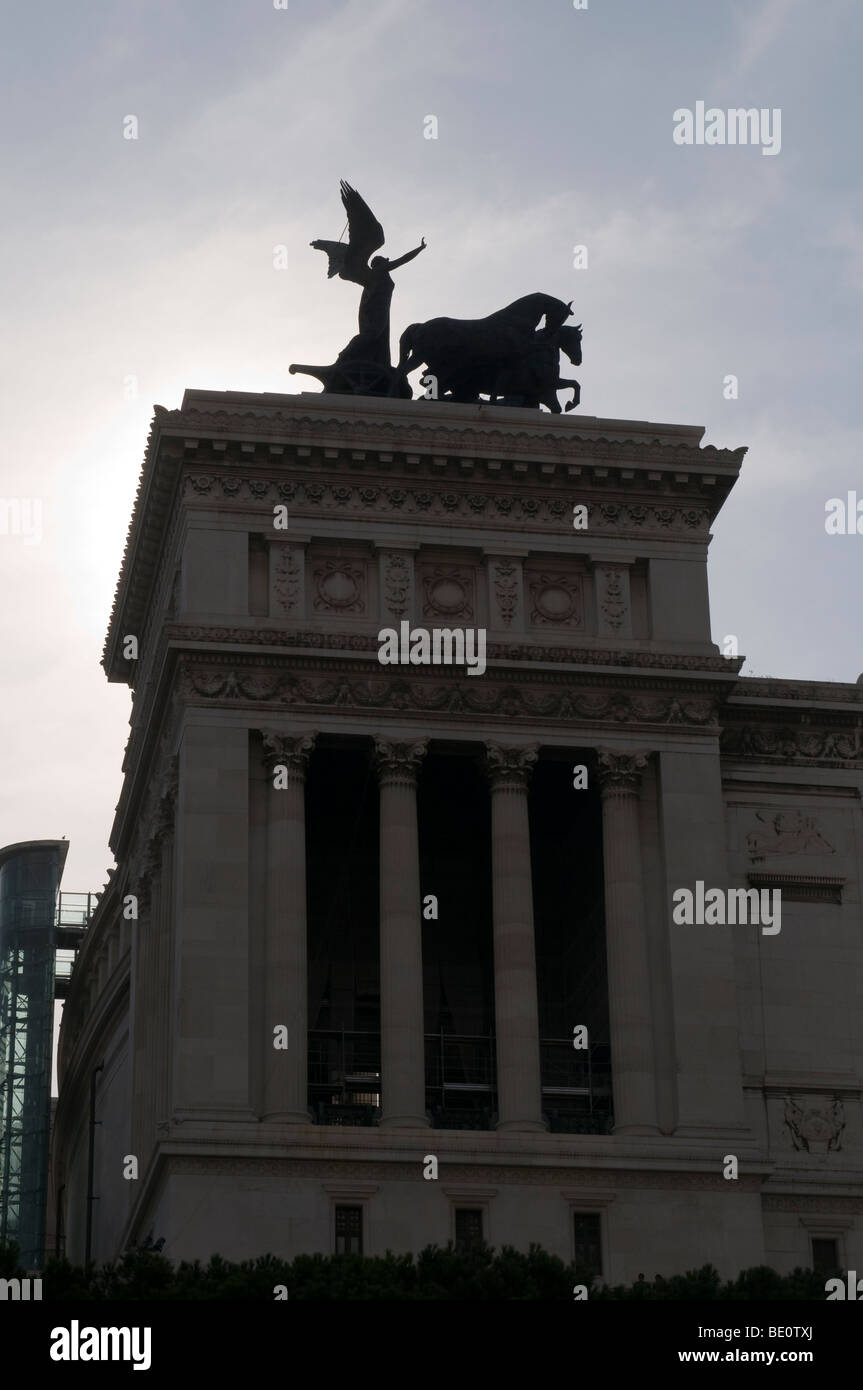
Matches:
[485,744,546,1130]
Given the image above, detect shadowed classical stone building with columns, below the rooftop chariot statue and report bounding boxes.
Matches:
[56,391,863,1282]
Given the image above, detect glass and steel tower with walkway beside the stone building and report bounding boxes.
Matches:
[0,840,96,1269]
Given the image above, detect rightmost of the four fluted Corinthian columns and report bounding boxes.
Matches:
[599,748,657,1134]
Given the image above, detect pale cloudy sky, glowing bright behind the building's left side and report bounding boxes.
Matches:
[0,0,863,891]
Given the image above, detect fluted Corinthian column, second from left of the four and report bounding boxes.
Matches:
[375,738,428,1125]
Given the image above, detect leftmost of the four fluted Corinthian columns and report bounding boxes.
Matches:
[263,730,315,1125]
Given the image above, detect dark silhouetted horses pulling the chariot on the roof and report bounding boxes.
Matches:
[396,293,581,414]
